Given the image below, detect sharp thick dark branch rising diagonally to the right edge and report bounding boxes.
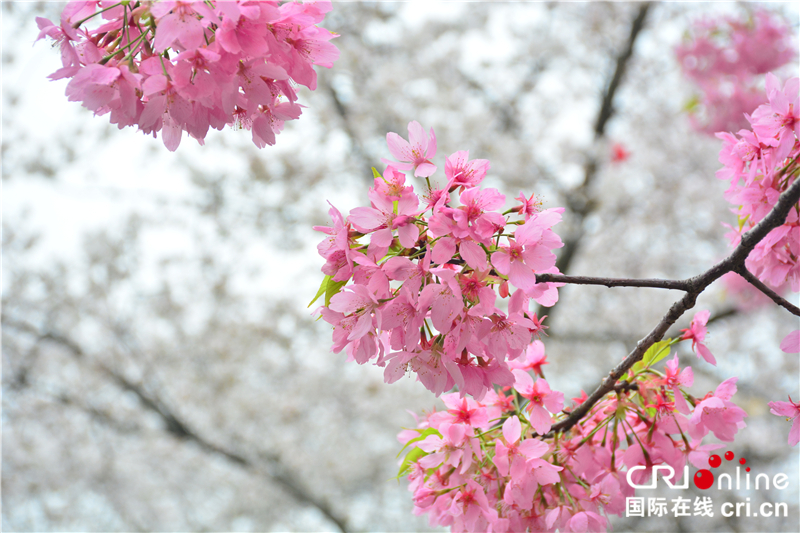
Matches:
[545,180,800,437]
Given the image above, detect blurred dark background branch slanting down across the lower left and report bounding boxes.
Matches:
[3,317,347,533]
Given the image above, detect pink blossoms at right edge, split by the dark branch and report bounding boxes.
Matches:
[717,74,800,292]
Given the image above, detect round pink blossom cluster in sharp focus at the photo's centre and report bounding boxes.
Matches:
[312,122,563,399]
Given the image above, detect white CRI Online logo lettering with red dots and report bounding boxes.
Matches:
[627,451,789,490]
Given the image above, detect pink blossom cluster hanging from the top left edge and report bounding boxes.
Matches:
[36,0,339,151]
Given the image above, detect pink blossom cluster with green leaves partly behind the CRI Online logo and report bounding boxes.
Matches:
[398,339,747,533]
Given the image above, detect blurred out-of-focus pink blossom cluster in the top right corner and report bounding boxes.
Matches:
[676,9,795,134]
